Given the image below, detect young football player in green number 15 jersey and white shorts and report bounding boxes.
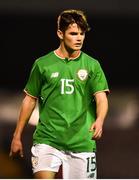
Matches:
[10,9,109,179]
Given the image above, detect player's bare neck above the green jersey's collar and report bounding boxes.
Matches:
[55,46,81,59]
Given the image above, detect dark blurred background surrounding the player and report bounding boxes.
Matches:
[0,0,139,178]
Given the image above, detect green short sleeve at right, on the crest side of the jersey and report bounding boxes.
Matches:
[90,61,109,94]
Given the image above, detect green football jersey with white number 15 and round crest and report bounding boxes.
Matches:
[25,51,109,152]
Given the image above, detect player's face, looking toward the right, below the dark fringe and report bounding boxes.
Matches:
[63,23,85,51]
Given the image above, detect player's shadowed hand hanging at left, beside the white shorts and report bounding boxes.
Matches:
[9,137,23,158]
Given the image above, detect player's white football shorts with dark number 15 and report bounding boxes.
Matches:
[31,144,97,179]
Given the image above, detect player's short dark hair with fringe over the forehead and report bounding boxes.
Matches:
[57,9,90,32]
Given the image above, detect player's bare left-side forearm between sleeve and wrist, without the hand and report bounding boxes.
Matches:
[14,96,36,139]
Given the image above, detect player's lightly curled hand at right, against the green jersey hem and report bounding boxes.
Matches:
[90,121,103,140]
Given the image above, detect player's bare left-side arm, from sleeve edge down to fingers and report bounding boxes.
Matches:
[9,94,37,157]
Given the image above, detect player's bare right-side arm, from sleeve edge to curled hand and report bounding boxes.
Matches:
[90,92,108,139]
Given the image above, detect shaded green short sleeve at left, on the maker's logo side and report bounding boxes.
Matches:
[24,61,42,97]
